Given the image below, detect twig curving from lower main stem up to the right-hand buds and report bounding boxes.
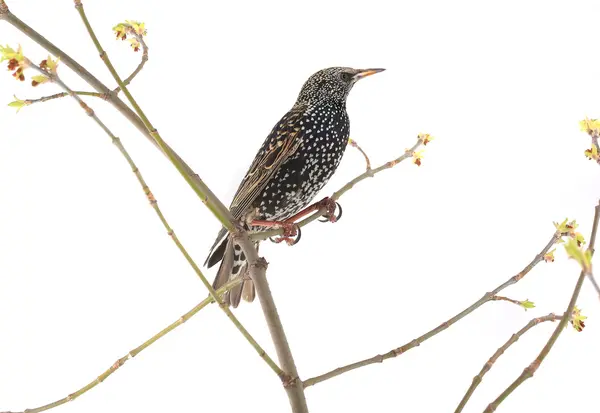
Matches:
[304,231,563,387]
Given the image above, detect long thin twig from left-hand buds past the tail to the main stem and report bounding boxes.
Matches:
[28,61,284,377]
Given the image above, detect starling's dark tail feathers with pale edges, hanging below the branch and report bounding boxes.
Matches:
[204,230,258,308]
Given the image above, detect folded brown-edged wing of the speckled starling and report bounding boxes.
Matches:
[230,105,306,218]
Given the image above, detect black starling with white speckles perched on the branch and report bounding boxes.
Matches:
[204,67,385,308]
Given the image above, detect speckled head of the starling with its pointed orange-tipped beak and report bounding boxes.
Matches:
[296,67,385,105]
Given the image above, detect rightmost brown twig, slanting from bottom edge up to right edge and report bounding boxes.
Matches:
[484,202,600,413]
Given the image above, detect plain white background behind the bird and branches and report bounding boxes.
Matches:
[0,0,600,413]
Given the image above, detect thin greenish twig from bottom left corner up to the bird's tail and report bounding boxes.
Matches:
[3,278,243,413]
